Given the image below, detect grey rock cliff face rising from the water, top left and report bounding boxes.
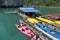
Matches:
[0,0,24,6]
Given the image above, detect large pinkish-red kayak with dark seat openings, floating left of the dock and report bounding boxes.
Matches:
[16,24,35,38]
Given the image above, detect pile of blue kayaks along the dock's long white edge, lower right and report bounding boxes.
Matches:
[36,24,60,40]
